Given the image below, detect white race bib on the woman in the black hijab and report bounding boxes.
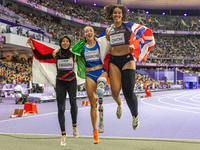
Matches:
[57,59,74,70]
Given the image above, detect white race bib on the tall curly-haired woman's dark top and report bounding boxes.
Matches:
[110,33,125,46]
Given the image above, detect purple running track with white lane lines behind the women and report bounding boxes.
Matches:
[0,90,200,140]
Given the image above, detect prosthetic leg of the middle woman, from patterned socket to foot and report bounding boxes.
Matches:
[97,77,107,133]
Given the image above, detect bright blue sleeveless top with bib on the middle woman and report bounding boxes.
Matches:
[83,41,102,68]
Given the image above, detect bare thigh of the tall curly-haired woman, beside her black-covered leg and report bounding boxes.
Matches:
[109,63,121,93]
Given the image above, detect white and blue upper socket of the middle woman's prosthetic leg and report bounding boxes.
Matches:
[97,77,107,97]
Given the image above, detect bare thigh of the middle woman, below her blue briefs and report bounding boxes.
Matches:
[86,77,97,101]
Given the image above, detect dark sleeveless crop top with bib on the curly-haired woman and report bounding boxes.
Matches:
[108,23,131,47]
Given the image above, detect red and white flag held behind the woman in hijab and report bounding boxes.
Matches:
[30,38,85,87]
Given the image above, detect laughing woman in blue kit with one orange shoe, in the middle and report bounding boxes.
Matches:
[72,26,108,144]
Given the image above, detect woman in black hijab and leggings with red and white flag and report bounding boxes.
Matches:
[27,36,79,146]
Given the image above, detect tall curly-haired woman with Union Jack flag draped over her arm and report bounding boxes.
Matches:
[104,5,155,130]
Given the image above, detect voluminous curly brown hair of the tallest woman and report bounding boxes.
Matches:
[103,5,128,21]
